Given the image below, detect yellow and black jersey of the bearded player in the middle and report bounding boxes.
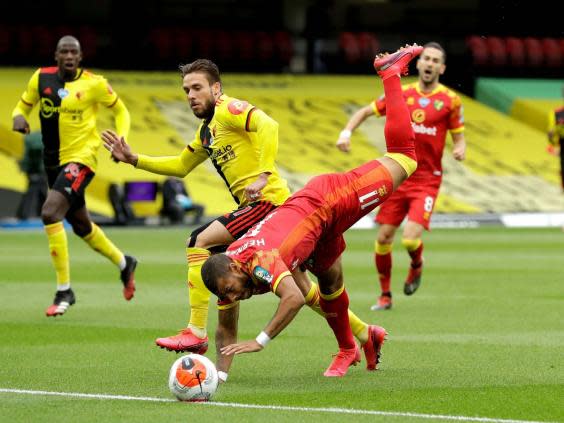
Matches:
[136,94,290,206]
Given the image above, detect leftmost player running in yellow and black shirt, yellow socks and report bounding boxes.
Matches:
[12,35,137,316]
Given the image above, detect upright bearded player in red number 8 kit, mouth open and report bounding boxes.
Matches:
[337,42,466,310]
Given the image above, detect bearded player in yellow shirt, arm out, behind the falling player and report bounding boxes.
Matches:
[102,59,378,368]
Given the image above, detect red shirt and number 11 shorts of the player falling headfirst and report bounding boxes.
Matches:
[225,160,393,293]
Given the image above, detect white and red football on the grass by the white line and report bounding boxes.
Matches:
[168,354,219,401]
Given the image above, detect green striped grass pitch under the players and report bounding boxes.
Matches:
[0,227,564,422]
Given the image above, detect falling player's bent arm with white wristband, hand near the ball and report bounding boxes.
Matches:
[221,276,305,355]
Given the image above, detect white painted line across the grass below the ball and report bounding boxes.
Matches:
[0,388,553,423]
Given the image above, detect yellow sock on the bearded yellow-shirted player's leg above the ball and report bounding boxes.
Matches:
[186,247,211,338]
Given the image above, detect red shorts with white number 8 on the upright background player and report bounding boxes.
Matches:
[374,181,439,230]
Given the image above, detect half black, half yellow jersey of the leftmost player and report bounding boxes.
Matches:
[12,67,129,171]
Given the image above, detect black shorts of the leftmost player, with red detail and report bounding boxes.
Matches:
[45,162,94,210]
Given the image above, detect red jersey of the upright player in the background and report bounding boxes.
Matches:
[372,82,464,186]
